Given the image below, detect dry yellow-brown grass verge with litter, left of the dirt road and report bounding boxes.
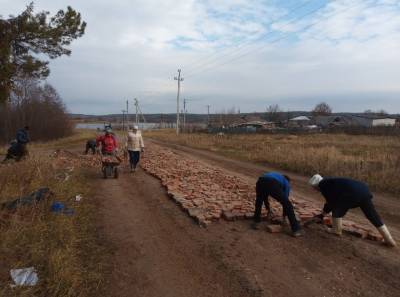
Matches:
[0,133,107,297]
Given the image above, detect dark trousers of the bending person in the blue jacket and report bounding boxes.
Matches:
[254,177,300,232]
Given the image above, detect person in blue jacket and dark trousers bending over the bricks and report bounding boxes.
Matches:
[252,172,303,237]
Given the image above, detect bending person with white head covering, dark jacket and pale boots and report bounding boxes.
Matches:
[309,174,396,246]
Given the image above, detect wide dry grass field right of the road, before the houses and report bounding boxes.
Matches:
[145,130,400,194]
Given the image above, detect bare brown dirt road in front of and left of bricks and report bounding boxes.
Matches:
[90,143,400,297]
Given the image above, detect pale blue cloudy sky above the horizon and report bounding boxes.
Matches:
[0,0,400,114]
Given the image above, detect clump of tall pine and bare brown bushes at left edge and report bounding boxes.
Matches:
[0,3,86,143]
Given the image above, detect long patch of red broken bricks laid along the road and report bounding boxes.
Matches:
[141,144,381,240]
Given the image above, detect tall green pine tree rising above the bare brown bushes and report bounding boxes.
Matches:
[0,2,86,104]
